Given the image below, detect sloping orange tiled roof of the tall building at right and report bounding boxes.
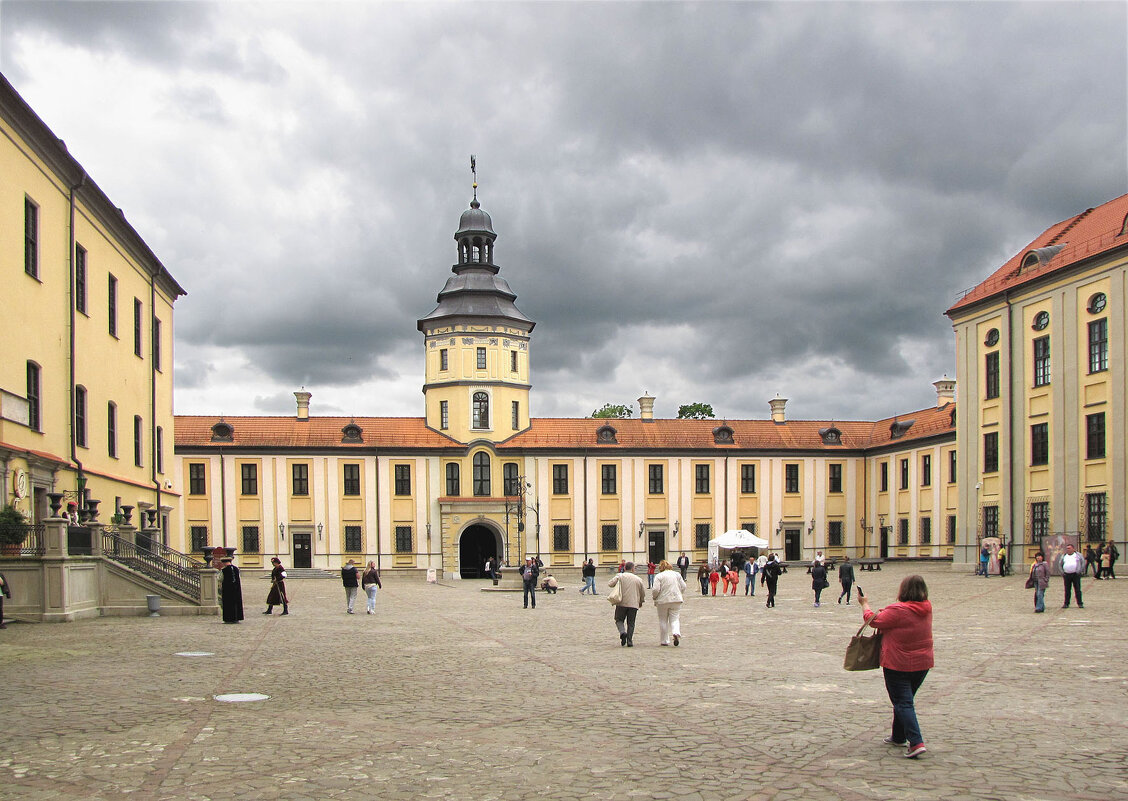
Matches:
[945,194,1128,317]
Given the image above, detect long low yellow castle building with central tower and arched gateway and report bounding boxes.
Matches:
[176,194,959,578]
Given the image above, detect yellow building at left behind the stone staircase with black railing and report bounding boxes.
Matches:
[0,76,185,539]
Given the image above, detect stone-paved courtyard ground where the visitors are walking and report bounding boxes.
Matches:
[0,565,1128,801]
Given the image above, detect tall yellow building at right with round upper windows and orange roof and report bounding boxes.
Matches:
[948,195,1128,568]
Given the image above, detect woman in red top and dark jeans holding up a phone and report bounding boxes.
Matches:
[858,575,933,759]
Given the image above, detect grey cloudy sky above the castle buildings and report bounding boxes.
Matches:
[0,0,1128,420]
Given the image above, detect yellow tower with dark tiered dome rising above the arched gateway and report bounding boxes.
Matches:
[418,183,536,442]
